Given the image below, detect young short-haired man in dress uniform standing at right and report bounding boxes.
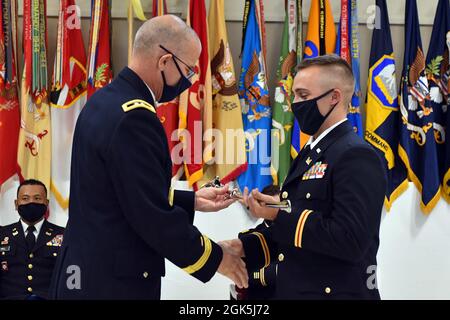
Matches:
[222,55,387,299]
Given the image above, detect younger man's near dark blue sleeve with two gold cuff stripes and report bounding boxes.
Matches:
[272,147,387,262]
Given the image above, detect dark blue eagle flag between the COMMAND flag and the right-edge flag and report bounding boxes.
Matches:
[399,0,440,214]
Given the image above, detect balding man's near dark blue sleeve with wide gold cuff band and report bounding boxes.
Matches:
[106,109,222,282]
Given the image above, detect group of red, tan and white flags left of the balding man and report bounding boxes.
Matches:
[0,0,112,209]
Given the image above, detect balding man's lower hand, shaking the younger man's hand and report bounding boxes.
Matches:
[217,243,248,289]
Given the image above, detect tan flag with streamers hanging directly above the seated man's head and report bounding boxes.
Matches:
[17,0,52,190]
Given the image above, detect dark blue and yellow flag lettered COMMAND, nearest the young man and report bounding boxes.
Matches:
[365,0,408,211]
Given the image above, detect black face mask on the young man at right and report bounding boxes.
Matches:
[292,89,337,136]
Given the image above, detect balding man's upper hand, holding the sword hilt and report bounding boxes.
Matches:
[195,184,236,212]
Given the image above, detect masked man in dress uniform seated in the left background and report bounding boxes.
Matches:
[0,180,64,299]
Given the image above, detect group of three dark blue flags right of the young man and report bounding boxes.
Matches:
[365,0,450,213]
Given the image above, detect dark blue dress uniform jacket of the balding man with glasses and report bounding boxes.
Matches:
[52,68,222,299]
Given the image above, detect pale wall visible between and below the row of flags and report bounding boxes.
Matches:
[0,0,450,299]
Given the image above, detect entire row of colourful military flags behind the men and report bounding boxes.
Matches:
[0,0,450,213]
